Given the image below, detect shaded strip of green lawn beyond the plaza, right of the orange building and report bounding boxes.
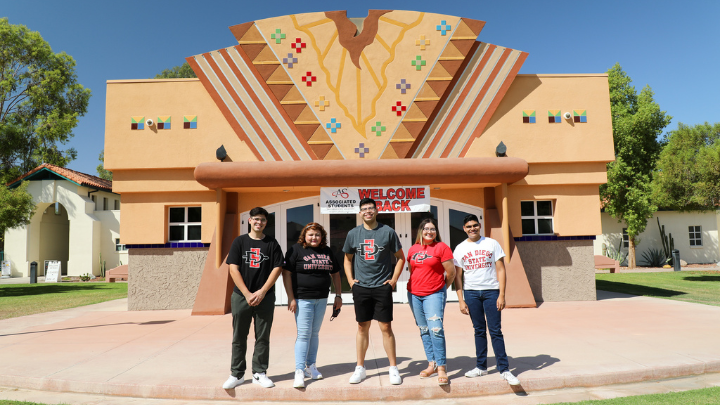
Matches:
[595,271,720,306]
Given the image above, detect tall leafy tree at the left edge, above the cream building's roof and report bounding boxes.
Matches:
[0,18,90,183]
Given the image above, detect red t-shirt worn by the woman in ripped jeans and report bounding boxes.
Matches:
[407,242,453,297]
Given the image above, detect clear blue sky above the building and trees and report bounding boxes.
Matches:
[0,0,720,175]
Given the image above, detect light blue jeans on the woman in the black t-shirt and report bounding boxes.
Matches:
[295,298,327,370]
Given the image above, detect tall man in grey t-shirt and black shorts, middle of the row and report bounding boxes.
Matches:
[343,198,405,385]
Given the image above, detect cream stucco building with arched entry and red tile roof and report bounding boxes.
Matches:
[5,163,128,277]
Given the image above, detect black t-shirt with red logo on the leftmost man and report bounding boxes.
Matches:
[227,234,283,294]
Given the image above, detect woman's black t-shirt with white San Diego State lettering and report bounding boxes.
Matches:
[284,243,340,300]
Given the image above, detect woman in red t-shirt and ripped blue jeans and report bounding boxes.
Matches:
[407,218,455,385]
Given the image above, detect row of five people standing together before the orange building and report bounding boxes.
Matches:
[223,202,520,389]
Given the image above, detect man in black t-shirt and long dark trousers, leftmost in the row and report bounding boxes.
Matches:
[223,207,283,389]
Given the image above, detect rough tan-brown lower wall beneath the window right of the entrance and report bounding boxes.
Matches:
[515,240,597,302]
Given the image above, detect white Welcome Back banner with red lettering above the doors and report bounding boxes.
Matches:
[320,186,430,214]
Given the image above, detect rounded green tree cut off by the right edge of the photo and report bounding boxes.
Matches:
[652,122,720,211]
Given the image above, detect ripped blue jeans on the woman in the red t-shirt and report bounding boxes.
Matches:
[408,286,447,366]
